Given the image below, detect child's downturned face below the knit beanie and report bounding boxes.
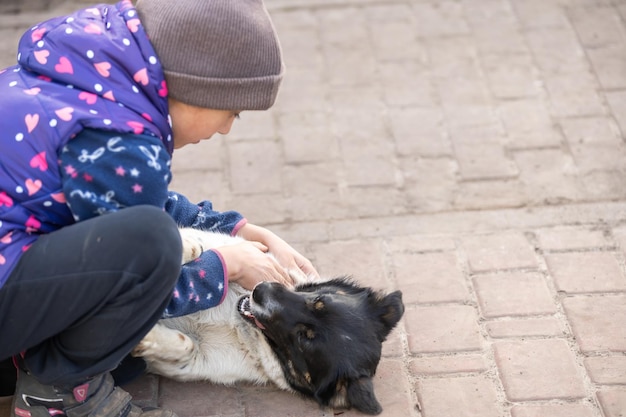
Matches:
[169,98,239,149]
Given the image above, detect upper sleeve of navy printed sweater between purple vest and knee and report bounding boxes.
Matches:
[60,129,170,220]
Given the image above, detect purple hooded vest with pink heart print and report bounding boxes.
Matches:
[0,0,173,287]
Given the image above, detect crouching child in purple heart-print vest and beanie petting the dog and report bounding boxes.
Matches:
[0,0,317,417]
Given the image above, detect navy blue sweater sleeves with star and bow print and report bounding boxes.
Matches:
[59,129,246,317]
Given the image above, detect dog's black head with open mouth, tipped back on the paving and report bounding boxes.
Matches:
[239,278,404,414]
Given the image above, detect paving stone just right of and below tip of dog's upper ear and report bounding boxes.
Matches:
[404,305,483,354]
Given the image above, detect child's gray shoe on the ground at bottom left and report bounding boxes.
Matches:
[11,369,177,417]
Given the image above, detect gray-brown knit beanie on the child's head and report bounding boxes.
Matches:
[136,0,284,110]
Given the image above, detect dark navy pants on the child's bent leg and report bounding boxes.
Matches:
[0,206,182,385]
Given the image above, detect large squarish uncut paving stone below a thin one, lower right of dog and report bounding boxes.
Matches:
[494,339,586,401]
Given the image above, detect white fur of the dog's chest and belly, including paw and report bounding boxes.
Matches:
[133,229,290,390]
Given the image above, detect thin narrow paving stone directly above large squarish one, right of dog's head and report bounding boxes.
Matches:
[485,317,565,339]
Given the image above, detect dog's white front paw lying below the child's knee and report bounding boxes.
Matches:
[132,323,194,363]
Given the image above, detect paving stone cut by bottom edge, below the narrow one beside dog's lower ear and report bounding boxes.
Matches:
[417,376,503,417]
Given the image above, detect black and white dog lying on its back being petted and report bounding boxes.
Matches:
[133,229,404,414]
